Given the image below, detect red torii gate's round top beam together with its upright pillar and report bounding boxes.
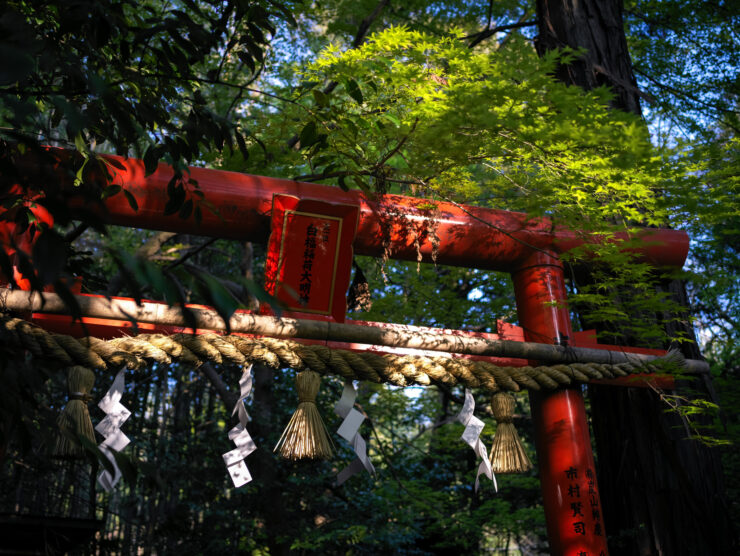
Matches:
[0,157,689,555]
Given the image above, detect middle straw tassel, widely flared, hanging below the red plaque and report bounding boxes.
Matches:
[274,371,334,460]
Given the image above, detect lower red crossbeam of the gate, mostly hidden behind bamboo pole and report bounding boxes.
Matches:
[31,312,675,389]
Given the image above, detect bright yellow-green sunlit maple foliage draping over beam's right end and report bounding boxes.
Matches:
[233,27,704,343]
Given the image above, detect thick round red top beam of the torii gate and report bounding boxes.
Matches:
[18,149,689,272]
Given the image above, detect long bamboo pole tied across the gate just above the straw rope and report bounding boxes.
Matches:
[0,288,709,374]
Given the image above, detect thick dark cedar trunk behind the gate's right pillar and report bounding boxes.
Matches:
[536,0,734,555]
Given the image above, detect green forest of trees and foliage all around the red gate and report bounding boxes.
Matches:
[0,0,740,554]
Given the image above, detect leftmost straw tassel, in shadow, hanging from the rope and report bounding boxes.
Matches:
[54,366,95,458]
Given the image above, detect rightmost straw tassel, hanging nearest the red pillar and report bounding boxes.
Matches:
[491,392,532,473]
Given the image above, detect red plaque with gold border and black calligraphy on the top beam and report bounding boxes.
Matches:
[265,195,359,322]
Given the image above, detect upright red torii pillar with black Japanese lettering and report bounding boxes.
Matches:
[512,251,608,556]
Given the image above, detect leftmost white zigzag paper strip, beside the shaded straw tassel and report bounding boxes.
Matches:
[95,368,131,492]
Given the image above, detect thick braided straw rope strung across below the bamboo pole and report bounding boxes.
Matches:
[0,316,682,392]
